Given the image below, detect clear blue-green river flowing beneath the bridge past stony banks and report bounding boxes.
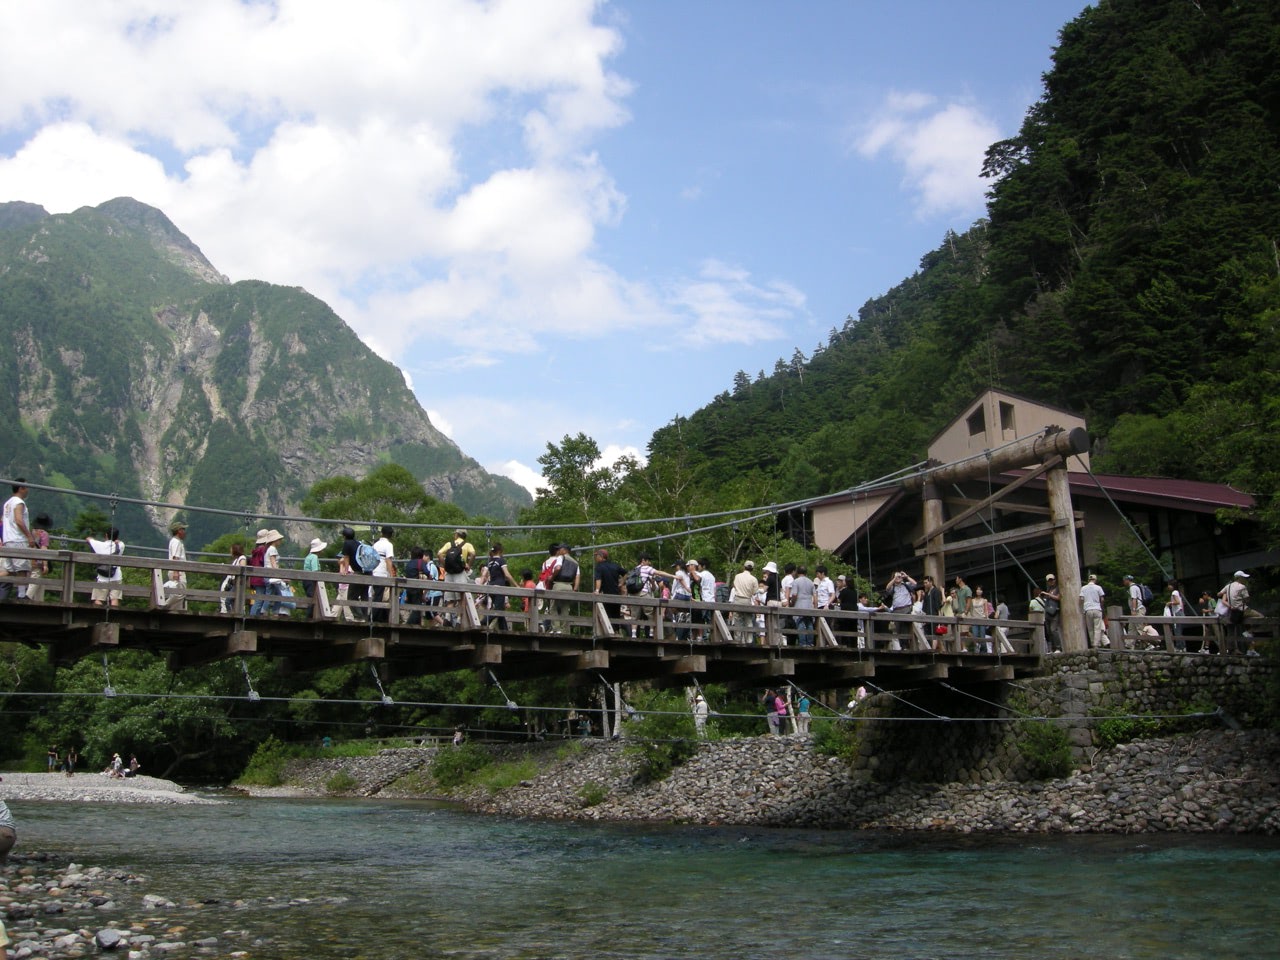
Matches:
[14,799,1280,960]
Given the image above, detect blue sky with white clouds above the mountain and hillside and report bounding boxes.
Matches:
[0,0,1084,488]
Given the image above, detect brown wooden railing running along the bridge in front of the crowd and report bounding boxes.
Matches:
[0,548,1276,658]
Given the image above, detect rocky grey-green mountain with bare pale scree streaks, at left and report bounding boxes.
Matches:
[0,198,529,543]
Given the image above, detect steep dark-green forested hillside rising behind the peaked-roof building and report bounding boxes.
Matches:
[632,0,1280,540]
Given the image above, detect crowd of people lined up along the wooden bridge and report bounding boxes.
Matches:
[0,477,1257,653]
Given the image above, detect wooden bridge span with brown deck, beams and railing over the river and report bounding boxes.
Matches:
[0,549,1044,689]
